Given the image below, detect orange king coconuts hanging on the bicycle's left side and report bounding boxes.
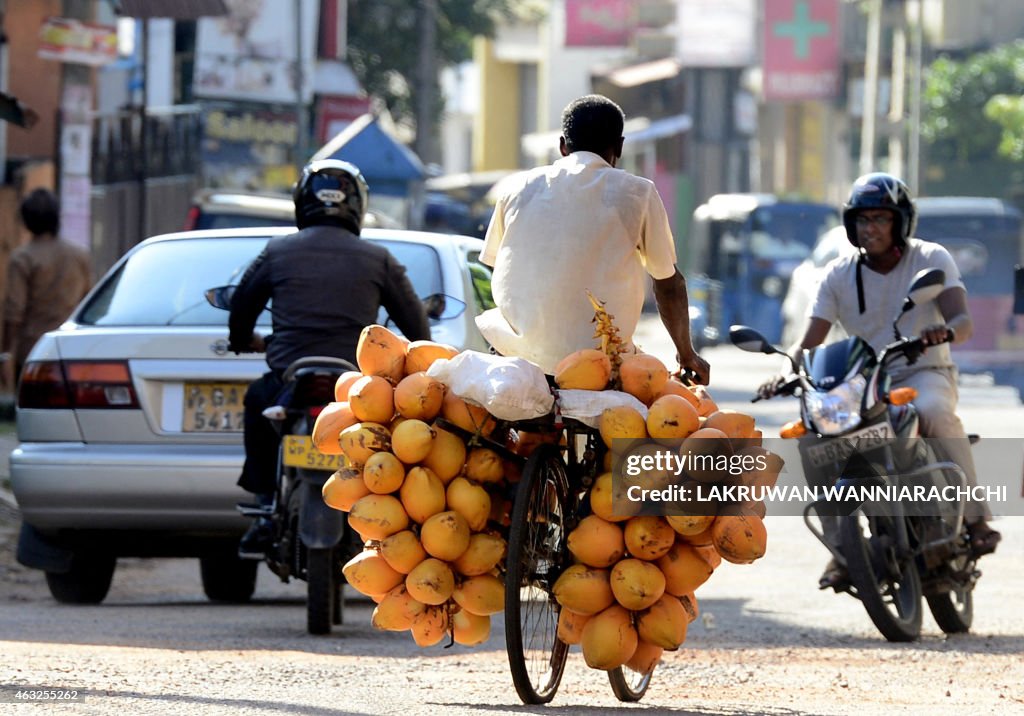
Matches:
[312,325,517,646]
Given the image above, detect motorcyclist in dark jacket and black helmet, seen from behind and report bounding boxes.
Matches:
[228,159,430,558]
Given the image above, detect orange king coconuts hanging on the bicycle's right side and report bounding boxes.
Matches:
[554,290,782,673]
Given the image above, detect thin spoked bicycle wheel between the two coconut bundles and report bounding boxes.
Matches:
[505,446,571,704]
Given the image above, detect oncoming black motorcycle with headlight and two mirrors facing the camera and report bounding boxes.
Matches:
[729,269,981,641]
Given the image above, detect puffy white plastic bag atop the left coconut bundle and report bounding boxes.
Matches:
[427,350,555,420]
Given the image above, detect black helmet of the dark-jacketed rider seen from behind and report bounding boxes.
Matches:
[292,159,370,234]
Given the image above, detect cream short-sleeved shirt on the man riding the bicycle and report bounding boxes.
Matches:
[476,152,676,373]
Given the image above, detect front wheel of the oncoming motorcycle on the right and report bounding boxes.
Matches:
[840,510,922,641]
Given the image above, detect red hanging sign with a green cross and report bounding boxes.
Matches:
[763,0,842,100]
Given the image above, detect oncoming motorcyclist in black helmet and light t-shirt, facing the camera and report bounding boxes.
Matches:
[759,172,1000,588]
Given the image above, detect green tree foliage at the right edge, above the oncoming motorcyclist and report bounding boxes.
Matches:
[921,40,1024,163]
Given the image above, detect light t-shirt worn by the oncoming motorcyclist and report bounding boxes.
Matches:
[810,239,964,369]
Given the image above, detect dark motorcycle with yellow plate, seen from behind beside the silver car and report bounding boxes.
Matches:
[207,286,362,634]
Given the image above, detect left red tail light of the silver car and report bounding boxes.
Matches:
[17,361,138,409]
